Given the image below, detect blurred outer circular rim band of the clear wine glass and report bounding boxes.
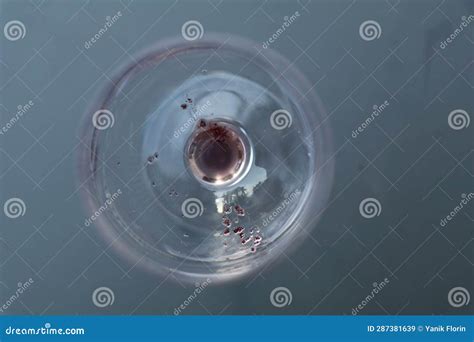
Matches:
[77,33,335,282]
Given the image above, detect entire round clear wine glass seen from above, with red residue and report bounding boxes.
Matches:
[79,35,333,281]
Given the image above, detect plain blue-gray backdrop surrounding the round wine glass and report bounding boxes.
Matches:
[0,0,474,315]
